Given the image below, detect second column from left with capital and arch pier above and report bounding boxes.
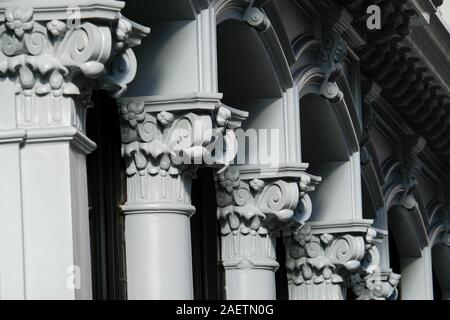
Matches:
[120,1,230,299]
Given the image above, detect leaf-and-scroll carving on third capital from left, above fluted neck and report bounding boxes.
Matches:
[216,167,320,236]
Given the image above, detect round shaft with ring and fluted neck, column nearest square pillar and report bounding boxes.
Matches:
[122,173,195,300]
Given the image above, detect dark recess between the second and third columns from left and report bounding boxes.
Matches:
[191,168,220,300]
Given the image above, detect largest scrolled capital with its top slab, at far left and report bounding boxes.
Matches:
[0,0,150,115]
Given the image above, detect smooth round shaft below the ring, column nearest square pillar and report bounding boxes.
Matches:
[125,213,193,300]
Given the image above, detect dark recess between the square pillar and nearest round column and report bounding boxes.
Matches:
[87,92,126,300]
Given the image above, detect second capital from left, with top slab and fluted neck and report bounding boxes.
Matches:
[119,95,247,204]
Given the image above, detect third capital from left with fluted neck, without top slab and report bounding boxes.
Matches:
[216,167,320,270]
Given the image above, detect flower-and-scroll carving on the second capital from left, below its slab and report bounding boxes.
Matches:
[120,101,239,177]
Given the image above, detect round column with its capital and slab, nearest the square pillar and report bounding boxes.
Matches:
[120,94,247,299]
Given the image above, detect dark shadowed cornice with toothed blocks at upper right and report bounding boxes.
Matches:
[338,0,450,164]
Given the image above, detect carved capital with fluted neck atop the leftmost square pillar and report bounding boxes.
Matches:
[0,1,149,132]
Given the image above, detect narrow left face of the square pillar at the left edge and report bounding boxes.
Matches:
[0,77,26,299]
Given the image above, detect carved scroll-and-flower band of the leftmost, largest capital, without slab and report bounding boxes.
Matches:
[0,7,149,96]
